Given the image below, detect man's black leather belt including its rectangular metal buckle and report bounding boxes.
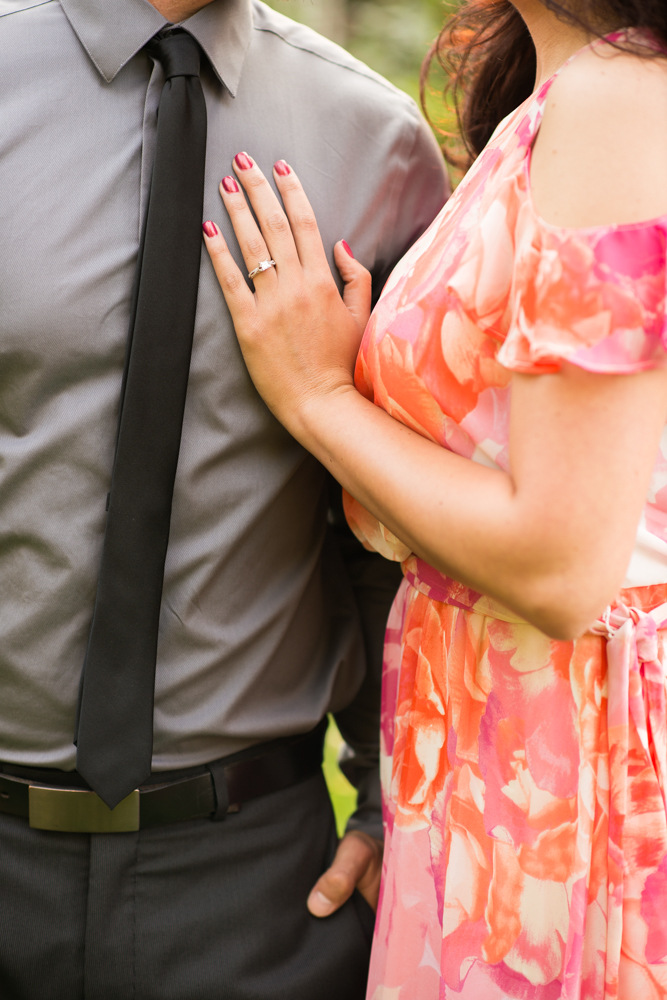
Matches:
[0,719,327,833]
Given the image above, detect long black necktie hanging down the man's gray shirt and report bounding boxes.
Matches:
[75,30,206,809]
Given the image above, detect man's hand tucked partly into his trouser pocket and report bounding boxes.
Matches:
[308,830,383,917]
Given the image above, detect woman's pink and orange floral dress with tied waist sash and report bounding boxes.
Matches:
[346,33,667,1000]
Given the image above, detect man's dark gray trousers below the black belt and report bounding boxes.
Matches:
[0,775,374,1000]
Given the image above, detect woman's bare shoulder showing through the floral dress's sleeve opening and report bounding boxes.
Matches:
[531,39,667,228]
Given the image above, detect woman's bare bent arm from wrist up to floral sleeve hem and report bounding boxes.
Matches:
[291,367,667,639]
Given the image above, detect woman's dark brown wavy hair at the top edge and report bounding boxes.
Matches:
[421,0,667,168]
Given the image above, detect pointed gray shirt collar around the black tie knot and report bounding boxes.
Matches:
[60,0,252,96]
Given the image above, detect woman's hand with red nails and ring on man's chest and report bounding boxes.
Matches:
[204,153,371,437]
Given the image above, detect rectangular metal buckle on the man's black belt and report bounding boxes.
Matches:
[28,785,139,833]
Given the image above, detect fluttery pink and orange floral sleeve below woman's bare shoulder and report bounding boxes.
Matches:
[497,216,667,374]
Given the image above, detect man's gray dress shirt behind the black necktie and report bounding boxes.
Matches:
[0,0,446,820]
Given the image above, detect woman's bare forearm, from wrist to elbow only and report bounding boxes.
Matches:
[296,387,586,634]
